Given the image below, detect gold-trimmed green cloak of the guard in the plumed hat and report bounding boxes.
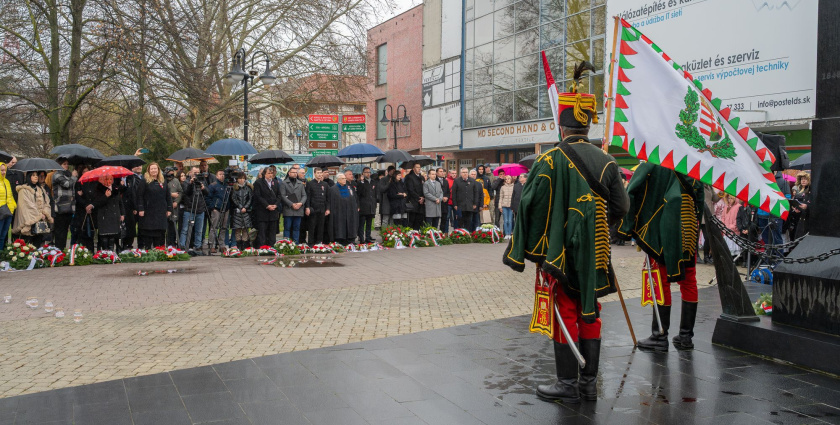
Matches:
[503,142,615,322]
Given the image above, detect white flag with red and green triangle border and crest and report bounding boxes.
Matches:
[606,17,790,219]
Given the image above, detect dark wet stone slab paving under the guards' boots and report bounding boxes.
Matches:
[0,287,840,425]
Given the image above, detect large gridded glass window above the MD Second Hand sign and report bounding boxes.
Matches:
[464,0,607,128]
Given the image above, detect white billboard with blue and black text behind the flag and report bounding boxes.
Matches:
[607,0,818,124]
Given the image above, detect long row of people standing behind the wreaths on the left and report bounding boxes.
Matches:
[0,158,527,255]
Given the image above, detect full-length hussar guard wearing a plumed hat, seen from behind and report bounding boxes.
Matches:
[503,62,629,403]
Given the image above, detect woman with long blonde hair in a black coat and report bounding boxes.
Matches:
[135,162,172,249]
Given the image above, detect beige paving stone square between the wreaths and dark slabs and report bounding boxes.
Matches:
[0,244,714,397]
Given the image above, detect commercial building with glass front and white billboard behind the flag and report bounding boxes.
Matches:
[390,0,816,168]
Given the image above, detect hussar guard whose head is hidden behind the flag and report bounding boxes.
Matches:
[618,162,703,351]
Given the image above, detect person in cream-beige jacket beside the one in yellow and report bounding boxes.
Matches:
[12,171,53,246]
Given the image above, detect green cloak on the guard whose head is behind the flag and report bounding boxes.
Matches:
[618,162,703,282]
